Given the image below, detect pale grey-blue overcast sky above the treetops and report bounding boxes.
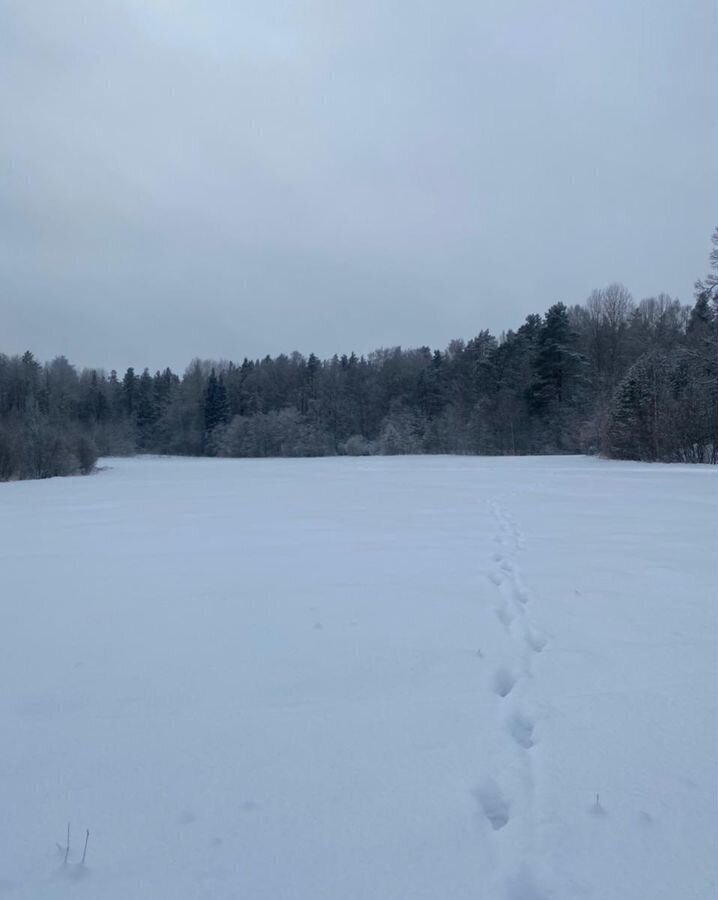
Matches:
[0,0,718,370]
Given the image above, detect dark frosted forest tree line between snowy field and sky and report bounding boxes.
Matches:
[0,229,718,480]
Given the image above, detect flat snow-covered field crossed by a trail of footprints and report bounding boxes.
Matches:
[0,457,718,900]
